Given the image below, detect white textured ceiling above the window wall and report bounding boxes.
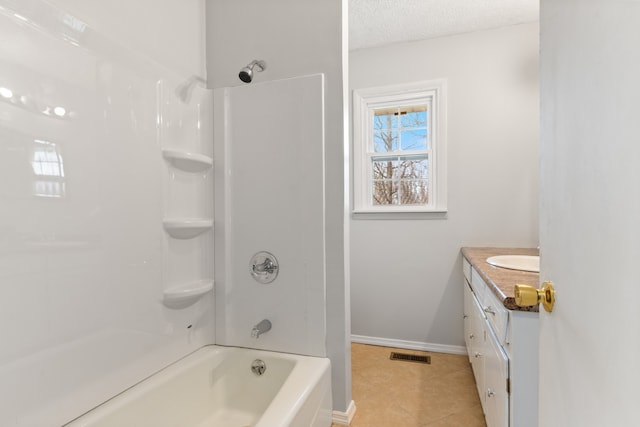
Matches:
[349,0,539,50]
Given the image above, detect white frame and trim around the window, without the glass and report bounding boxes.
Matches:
[352,79,447,214]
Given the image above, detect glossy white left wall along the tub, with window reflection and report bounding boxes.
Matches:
[0,0,214,426]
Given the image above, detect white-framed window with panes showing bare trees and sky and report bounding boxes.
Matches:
[353,80,446,213]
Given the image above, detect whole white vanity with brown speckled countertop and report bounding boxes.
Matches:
[462,247,539,427]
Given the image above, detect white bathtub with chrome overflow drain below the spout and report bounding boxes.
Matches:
[65,345,331,427]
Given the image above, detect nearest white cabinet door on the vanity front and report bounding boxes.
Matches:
[480,323,509,427]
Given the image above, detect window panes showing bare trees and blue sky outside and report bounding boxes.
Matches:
[371,105,429,205]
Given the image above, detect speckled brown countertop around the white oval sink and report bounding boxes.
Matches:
[462,248,539,311]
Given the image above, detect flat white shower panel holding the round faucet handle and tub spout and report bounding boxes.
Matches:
[214,75,326,356]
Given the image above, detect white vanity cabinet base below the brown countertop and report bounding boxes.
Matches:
[463,254,538,427]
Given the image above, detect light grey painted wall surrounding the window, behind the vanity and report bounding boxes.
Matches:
[349,23,539,351]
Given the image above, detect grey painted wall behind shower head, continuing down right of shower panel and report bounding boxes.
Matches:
[206,0,351,411]
